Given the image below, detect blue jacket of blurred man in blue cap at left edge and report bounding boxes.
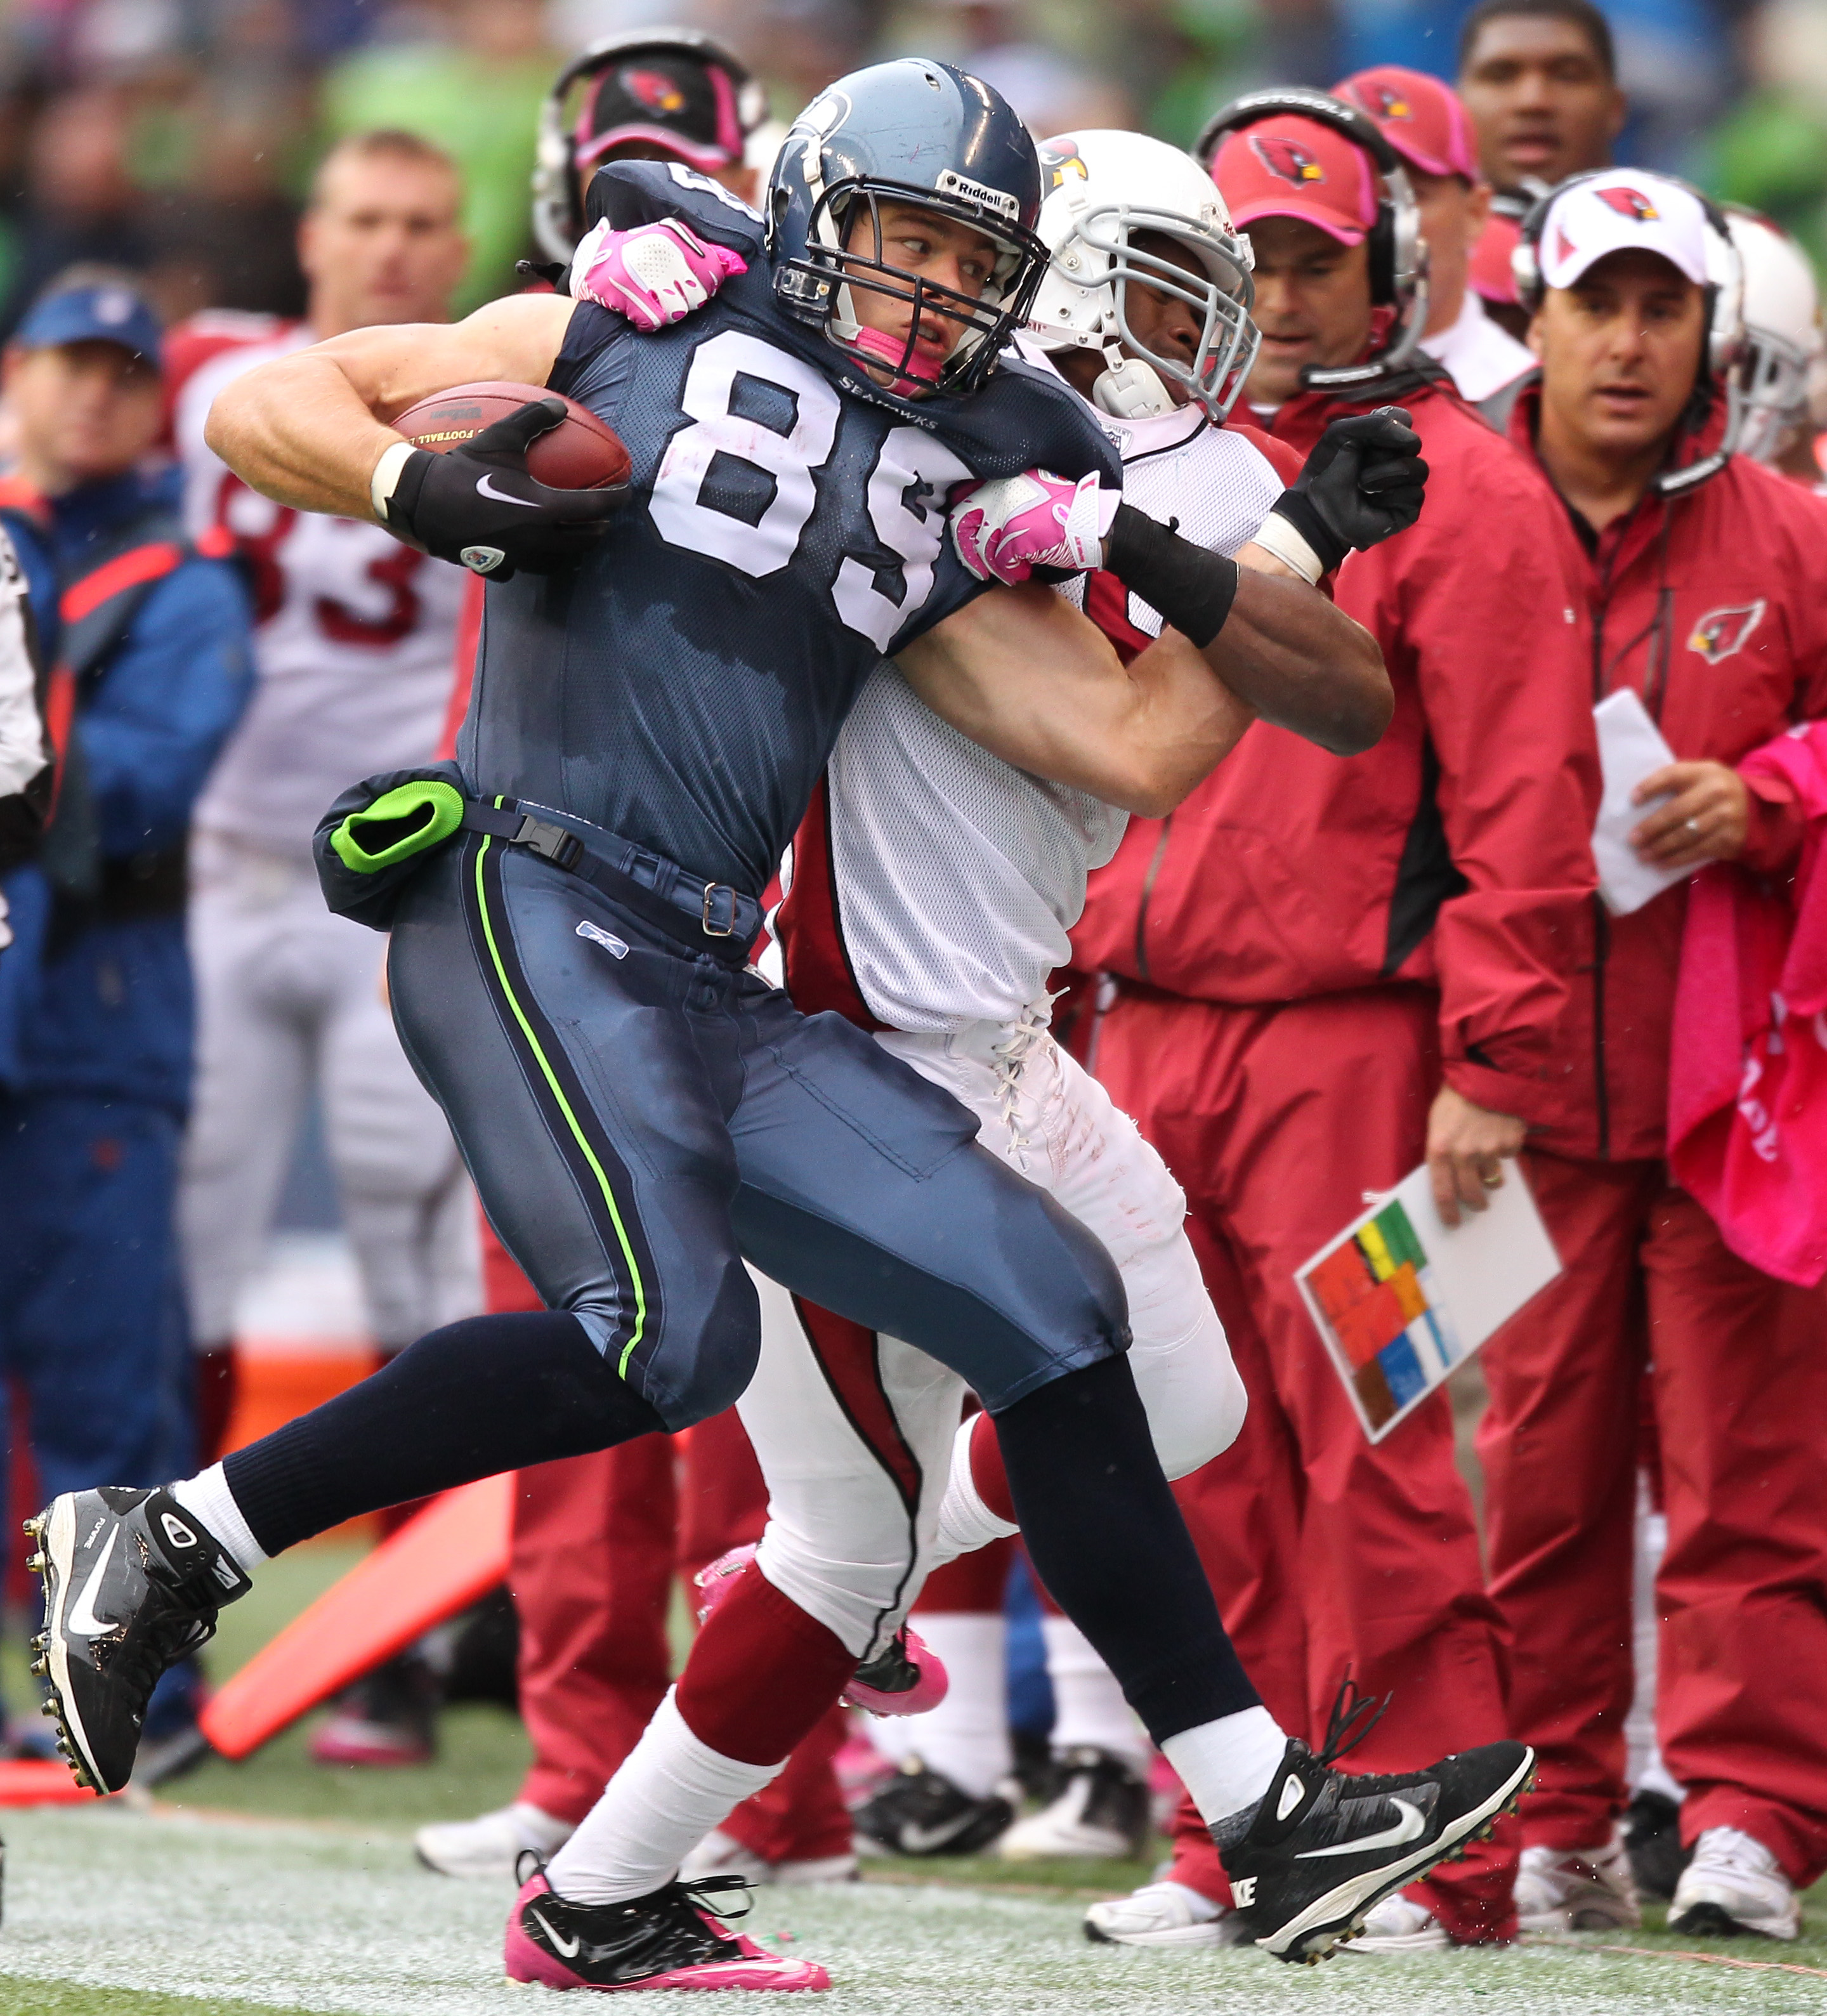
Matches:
[0,472,254,1115]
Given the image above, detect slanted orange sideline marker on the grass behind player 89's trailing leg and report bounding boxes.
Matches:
[200,1472,514,1760]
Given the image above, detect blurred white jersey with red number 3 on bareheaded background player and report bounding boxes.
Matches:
[167,313,464,859]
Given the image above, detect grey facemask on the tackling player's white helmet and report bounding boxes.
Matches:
[1059,204,1262,421]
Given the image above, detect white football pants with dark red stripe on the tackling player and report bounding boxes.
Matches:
[736,1012,1244,1659]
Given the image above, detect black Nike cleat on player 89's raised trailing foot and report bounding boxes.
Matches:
[26,1486,252,1792]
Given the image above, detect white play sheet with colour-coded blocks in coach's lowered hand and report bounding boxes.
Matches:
[1295,1162,1561,1441]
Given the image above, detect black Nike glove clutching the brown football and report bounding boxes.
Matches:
[387,397,627,580]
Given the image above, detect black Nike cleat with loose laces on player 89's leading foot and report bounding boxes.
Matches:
[1214,1679,1535,1961]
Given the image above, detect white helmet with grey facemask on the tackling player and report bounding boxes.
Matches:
[1028,133,1261,419]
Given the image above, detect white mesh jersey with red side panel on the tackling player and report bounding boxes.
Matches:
[778,389,1283,1032]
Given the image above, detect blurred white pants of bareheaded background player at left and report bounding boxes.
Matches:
[180,833,482,1351]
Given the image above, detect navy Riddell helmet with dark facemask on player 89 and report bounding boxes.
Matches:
[766,56,1047,391]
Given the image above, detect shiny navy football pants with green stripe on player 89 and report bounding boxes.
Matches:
[390,837,1127,1429]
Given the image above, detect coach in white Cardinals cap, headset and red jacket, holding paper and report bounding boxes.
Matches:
[1476,169,1827,1939]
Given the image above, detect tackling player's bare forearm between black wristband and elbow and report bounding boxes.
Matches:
[1204,568,1396,756]
